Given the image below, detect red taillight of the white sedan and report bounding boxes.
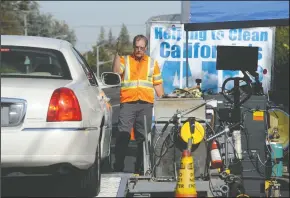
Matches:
[46,87,82,122]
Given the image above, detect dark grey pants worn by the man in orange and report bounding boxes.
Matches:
[114,101,153,172]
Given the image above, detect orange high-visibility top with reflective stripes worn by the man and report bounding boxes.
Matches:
[120,55,162,103]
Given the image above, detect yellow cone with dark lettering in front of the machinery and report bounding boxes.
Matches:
[175,150,197,197]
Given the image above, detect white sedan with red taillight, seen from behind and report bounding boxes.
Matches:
[0,35,118,196]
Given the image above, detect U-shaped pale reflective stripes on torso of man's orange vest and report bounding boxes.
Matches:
[121,56,154,89]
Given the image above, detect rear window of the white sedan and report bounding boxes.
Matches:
[0,45,72,80]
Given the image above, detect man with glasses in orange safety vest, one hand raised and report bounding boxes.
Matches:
[113,35,164,174]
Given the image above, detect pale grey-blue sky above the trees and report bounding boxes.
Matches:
[38,1,181,52]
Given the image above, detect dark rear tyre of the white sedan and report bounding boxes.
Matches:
[74,144,101,197]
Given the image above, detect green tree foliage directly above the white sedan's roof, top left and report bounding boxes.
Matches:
[0,1,76,45]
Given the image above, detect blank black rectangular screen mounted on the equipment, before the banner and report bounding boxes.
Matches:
[216,46,258,72]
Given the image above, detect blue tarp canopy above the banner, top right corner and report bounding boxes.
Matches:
[189,1,289,23]
